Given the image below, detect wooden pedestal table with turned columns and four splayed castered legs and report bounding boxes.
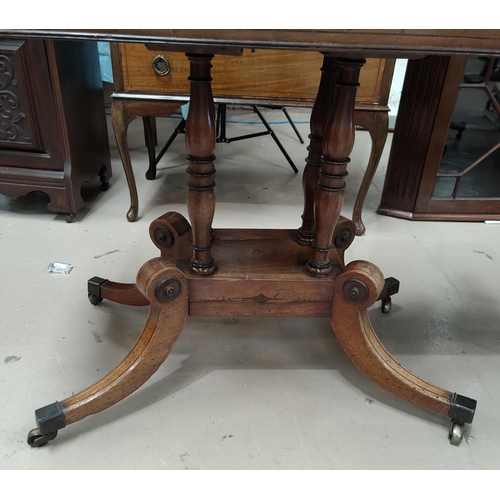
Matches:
[0,29,500,447]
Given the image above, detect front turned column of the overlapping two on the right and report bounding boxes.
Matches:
[306,58,365,277]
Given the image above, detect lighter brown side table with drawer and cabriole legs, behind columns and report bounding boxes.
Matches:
[111,43,395,235]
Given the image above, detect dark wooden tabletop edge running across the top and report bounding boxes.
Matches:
[0,29,500,57]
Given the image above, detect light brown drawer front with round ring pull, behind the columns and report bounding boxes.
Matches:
[118,44,386,105]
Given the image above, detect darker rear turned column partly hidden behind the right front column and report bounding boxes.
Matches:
[296,55,339,245]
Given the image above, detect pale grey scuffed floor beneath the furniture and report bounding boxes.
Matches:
[0,110,500,470]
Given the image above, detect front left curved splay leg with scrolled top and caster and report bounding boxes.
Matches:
[28,258,188,446]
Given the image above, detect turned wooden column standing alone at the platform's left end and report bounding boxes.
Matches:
[185,54,215,275]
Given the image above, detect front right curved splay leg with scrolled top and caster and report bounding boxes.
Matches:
[331,261,476,444]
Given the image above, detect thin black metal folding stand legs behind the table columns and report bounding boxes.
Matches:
[155,103,304,173]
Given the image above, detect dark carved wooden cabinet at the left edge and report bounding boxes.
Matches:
[0,38,111,222]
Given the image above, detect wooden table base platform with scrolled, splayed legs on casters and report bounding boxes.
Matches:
[28,212,476,447]
